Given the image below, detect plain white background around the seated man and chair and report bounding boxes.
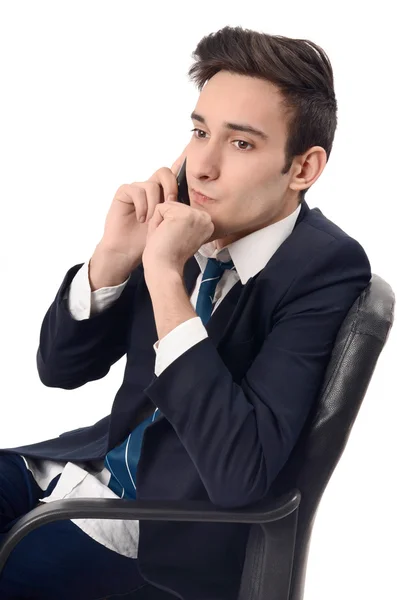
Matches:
[0,0,397,600]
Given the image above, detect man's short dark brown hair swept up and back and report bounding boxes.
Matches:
[188,26,337,202]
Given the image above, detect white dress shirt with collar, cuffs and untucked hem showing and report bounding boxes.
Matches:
[22,205,301,558]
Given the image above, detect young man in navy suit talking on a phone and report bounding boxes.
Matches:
[0,27,371,600]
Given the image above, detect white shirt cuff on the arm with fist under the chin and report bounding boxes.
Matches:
[153,317,208,377]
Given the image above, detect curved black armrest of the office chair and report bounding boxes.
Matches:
[0,490,301,573]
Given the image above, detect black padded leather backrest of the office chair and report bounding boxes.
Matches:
[269,275,395,600]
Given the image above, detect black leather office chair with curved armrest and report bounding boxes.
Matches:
[0,275,395,600]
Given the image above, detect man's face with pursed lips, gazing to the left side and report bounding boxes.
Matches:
[186,71,298,248]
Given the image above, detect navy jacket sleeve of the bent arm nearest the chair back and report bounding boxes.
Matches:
[145,238,371,507]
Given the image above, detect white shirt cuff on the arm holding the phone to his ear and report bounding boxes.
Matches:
[68,261,130,321]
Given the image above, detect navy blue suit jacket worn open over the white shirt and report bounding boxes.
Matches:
[4,202,371,600]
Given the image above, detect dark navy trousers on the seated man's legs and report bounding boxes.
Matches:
[0,454,159,600]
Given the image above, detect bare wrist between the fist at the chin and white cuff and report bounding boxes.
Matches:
[145,269,197,341]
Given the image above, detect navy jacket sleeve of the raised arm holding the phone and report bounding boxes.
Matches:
[37,263,143,390]
